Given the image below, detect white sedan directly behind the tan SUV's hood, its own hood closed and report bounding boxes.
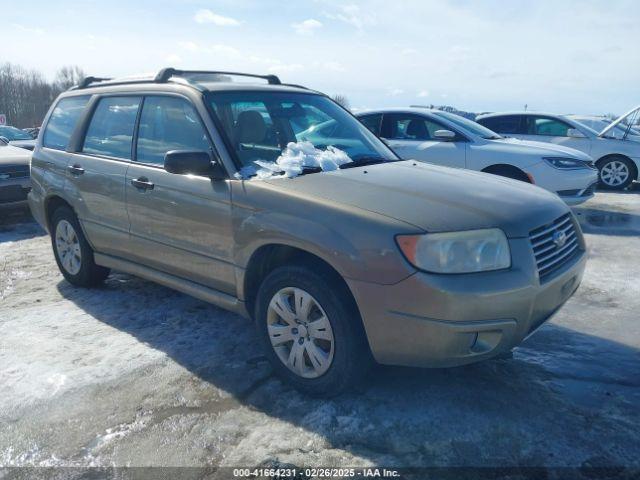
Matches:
[352,107,598,205]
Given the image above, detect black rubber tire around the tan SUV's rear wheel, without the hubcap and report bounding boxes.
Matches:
[51,206,109,287]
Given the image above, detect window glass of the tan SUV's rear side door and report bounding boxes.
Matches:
[82,97,140,159]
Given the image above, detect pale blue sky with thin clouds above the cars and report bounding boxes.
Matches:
[6,0,640,114]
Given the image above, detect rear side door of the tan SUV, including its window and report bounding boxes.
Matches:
[66,96,142,256]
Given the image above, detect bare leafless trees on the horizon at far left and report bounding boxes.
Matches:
[0,63,85,128]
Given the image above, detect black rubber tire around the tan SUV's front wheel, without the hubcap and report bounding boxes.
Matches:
[255,265,373,397]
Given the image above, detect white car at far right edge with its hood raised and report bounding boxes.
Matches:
[476,106,640,190]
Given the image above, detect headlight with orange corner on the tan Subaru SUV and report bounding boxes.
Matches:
[396,228,511,273]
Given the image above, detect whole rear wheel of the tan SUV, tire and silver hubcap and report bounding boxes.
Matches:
[51,207,109,287]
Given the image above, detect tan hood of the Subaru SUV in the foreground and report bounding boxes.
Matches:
[267,160,569,238]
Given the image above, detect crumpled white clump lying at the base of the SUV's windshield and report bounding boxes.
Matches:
[235,142,352,180]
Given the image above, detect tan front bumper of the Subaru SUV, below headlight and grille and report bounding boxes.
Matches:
[347,238,586,367]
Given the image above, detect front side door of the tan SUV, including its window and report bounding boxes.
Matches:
[126,95,235,294]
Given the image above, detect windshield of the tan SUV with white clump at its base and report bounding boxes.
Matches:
[208,91,398,173]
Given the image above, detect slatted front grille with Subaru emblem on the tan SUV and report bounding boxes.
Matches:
[529,213,580,282]
